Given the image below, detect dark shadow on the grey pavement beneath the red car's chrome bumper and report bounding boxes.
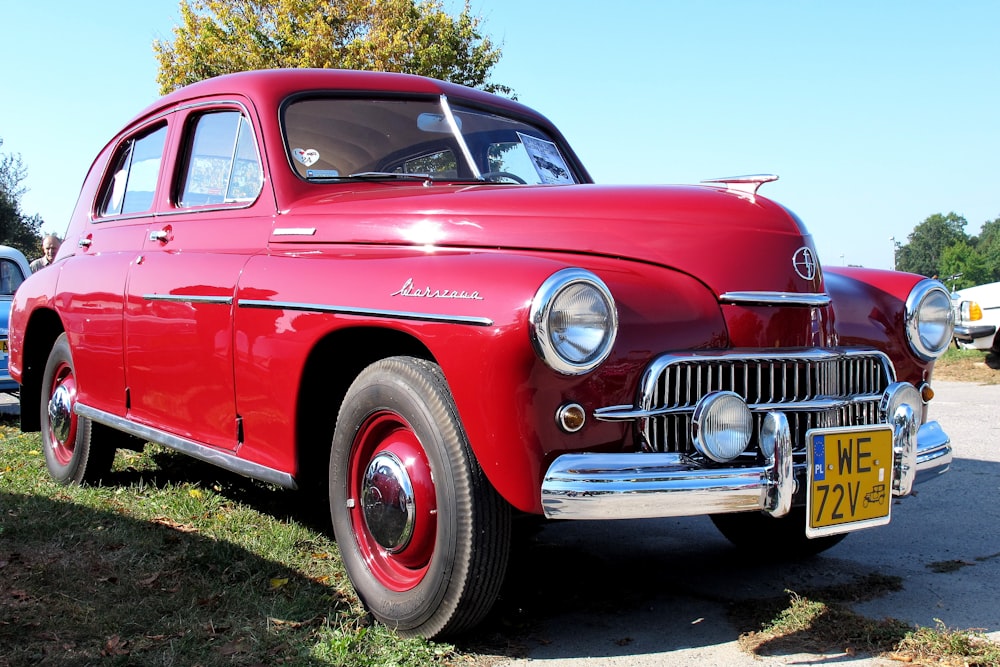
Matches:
[469,459,1000,664]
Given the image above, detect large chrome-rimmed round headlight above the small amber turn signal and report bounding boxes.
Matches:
[530,269,618,375]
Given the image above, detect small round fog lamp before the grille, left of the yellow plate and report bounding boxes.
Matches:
[691,391,753,463]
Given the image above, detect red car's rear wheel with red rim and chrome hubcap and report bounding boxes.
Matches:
[39,334,115,484]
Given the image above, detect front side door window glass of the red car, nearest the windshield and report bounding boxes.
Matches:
[177,111,263,208]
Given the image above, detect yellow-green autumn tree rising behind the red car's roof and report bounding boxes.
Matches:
[153,0,510,93]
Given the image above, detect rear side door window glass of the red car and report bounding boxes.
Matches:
[98,125,167,217]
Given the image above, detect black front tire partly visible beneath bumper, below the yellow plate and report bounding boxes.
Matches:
[712,507,847,560]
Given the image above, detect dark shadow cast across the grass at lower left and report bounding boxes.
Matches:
[0,491,350,665]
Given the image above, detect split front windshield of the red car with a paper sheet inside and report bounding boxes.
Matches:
[284,97,578,185]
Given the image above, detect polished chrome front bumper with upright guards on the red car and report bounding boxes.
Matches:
[542,412,952,519]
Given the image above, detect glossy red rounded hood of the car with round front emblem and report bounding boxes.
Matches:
[272,183,822,294]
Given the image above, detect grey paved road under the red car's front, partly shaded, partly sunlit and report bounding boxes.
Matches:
[501,382,1000,667]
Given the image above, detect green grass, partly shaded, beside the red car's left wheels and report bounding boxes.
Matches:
[0,422,480,667]
